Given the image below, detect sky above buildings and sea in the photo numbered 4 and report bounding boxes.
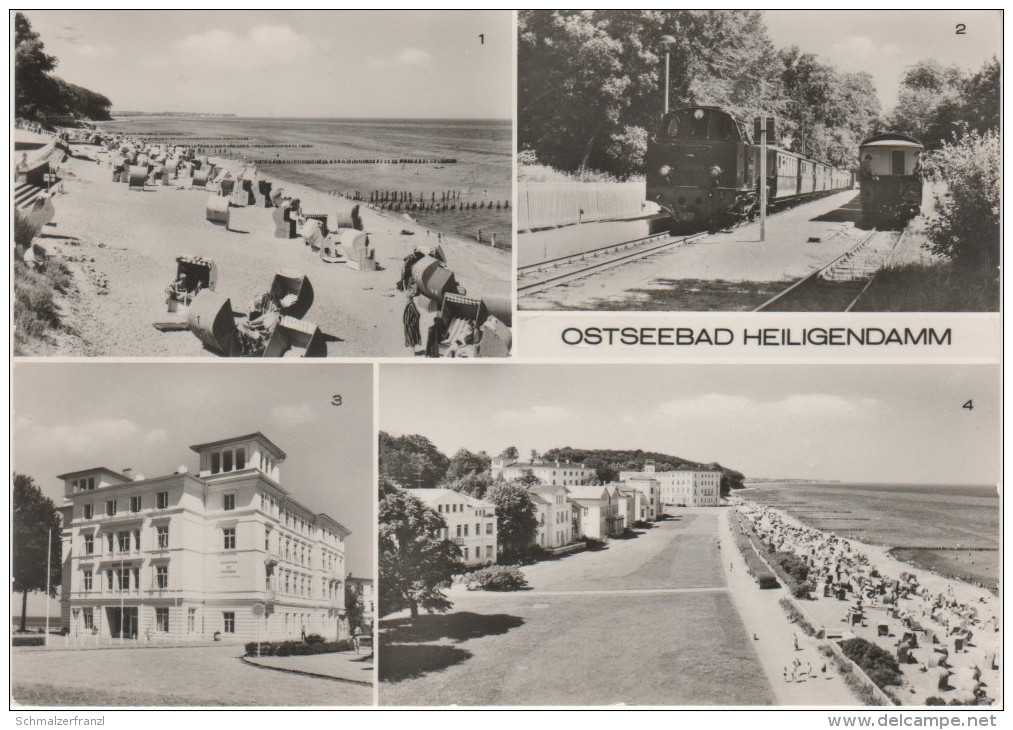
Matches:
[379,364,1001,485]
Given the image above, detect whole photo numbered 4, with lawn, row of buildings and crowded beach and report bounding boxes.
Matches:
[377,363,1003,708]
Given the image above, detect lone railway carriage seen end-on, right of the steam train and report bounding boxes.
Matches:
[858,133,925,228]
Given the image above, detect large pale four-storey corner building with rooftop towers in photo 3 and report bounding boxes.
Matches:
[59,432,349,641]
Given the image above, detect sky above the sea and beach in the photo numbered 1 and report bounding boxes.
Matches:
[25,10,514,119]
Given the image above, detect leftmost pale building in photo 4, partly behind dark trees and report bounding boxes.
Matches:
[407,488,497,567]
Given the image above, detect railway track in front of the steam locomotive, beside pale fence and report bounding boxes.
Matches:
[517,231,707,294]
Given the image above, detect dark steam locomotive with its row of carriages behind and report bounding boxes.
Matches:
[646,106,854,230]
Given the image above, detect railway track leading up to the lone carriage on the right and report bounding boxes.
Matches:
[753,231,907,312]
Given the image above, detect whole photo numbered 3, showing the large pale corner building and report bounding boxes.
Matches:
[10,362,376,707]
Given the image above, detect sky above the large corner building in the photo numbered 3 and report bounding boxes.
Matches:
[13,361,376,616]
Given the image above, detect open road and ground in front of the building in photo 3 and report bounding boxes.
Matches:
[10,646,373,707]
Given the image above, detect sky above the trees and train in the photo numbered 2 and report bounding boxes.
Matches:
[764,10,1002,111]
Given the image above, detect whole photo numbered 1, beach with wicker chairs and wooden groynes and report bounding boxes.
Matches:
[12,10,514,357]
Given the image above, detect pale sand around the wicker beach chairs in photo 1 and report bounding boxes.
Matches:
[24,140,511,357]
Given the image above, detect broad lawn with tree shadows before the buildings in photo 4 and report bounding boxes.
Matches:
[379,509,773,706]
